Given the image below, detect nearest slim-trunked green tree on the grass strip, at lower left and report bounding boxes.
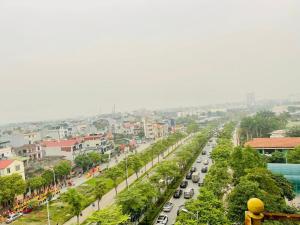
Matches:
[62,188,84,224]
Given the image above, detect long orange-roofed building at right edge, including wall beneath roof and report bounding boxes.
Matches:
[245,137,300,154]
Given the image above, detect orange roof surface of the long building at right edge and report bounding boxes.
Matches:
[245,137,300,148]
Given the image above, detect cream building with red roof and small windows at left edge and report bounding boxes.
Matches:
[0,159,25,180]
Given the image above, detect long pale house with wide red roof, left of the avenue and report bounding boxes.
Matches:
[41,138,83,161]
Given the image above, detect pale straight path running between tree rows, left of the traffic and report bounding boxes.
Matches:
[64,135,193,225]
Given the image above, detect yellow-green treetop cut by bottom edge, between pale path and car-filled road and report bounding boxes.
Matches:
[88,205,129,225]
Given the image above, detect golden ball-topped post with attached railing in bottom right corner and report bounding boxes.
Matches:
[245,198,300,225]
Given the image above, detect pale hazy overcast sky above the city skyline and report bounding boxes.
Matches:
[0,0,300,123]
